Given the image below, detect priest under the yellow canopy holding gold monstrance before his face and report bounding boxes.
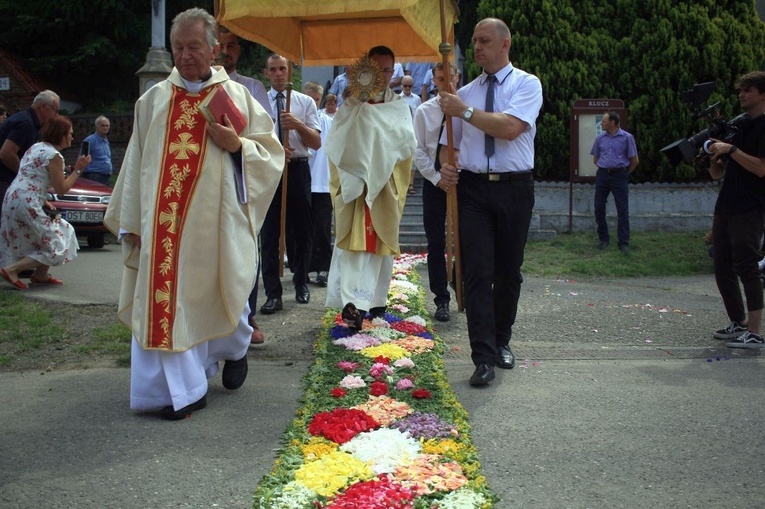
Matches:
[326,46,417,330]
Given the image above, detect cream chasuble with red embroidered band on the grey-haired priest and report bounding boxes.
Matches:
[104,68,284,351]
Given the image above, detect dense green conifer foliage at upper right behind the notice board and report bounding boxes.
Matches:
[478,0,765,181]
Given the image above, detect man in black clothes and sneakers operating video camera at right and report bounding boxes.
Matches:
[706,71,765,348]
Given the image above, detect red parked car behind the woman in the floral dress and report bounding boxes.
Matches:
[47,177,112,248]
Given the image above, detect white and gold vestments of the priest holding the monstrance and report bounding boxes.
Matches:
[326,89,417,255]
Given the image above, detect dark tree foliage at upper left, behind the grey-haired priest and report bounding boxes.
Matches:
[0,0,213,111]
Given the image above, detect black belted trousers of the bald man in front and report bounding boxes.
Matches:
[457,170,534,365]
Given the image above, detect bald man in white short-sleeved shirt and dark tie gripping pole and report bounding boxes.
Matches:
[439,18,542,386]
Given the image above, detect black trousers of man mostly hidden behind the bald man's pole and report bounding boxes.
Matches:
[422,180,450,305]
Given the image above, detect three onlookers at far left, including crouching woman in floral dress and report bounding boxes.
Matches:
[0,90,112,290]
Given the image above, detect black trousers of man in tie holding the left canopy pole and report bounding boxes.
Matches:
[260,158,313,299]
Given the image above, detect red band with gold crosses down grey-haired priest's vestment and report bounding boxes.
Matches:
[146,86,213,350]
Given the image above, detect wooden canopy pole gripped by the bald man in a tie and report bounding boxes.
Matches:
[438,0,465,311]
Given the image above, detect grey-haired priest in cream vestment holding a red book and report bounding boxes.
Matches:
[104,8,284,419]
